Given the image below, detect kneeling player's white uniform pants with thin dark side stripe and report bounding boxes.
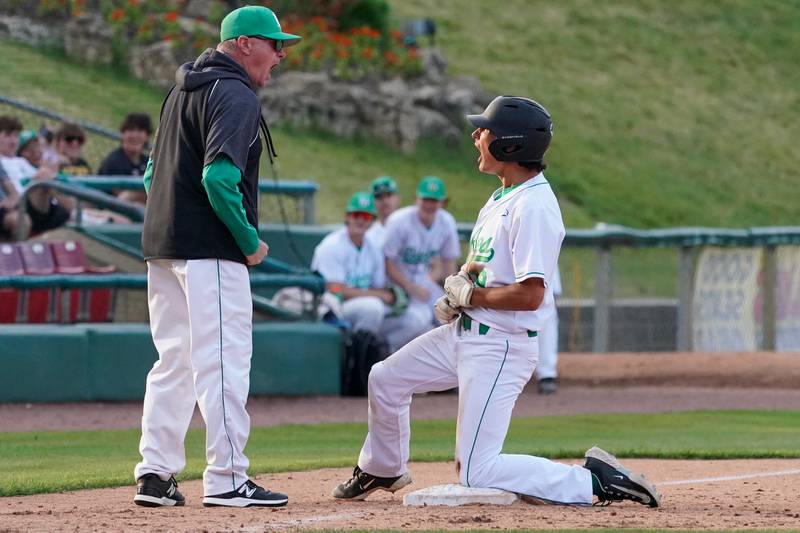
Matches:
[358,321,592,504]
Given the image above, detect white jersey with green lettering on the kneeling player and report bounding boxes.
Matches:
[467,173,566,333]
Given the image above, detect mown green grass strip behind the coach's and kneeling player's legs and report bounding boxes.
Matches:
[0,411,800,496]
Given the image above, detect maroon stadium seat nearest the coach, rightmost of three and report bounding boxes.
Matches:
[50,241,116,323]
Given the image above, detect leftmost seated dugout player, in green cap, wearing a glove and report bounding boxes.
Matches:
[311,192,428,350]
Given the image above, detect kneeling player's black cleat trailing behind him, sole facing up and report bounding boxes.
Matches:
[584,446,661,507]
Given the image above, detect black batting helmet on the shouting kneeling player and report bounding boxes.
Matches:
[467,96,553,163]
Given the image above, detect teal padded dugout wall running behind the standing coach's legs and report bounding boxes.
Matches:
[0,322,342,402]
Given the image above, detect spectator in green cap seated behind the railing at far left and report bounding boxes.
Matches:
[17,130,75,233]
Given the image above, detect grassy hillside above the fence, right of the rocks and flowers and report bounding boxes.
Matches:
[392,0,800,227]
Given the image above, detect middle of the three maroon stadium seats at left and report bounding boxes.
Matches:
[15,242,61,324]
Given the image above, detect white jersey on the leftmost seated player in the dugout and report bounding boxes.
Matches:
[311,227,386,289]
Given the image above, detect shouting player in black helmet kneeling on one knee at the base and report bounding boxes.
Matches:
[333,96,659,507]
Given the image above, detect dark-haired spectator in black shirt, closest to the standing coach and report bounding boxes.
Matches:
[97,113,153,204]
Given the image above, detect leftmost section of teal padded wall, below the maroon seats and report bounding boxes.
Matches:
[0,325,90,402]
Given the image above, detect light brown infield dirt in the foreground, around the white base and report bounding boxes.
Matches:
[0,459,800,531]
